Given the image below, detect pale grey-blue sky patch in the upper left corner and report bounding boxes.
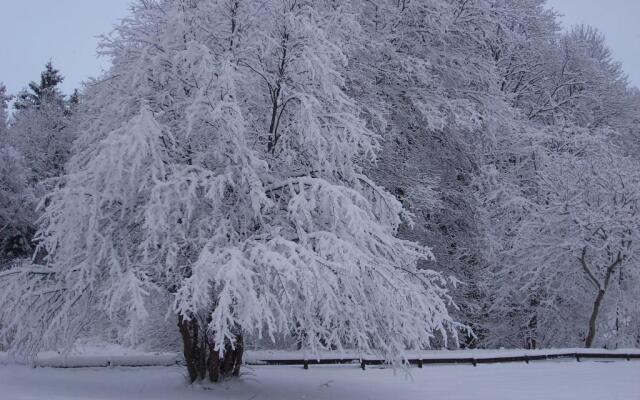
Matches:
[0,0,130,93]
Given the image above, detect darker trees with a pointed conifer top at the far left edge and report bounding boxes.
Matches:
[0,62,75,272]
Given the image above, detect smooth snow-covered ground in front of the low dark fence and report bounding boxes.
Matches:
[0,361,640,400]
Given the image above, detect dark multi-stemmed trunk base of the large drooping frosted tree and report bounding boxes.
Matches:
[178,316,244,383]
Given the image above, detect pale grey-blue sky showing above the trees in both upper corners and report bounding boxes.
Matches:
[0,0,640,97]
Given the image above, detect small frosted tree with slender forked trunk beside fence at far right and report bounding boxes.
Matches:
[513,132,640,347]
